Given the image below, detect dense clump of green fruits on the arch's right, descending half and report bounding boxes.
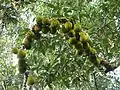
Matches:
[62,21,100,66]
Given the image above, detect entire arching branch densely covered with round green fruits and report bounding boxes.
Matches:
[12,17,116,81]
